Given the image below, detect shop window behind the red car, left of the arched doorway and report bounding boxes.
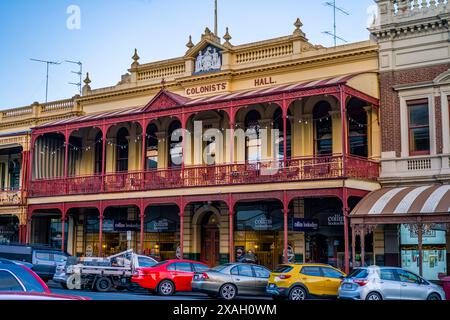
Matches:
[144,206,180,261]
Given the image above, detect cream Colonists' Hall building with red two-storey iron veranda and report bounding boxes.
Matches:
[0,20,383,271]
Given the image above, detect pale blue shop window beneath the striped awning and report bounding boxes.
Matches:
[400,225,447,280]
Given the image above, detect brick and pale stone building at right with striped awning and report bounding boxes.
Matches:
[352,0,450,280]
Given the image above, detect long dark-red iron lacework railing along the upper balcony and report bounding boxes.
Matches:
[29,155,379,197]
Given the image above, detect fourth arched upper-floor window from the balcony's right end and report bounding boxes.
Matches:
[245,110,261,161]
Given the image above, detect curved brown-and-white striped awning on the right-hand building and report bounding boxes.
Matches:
[350,185,450,218]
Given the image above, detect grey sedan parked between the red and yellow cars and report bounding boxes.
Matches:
[192,263,270,300]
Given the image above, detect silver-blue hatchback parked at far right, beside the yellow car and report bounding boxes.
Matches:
[339,266,445,300]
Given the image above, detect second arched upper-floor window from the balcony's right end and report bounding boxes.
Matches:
[313,101,333,156]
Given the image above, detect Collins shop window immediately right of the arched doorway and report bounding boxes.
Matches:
[235,202,292,269]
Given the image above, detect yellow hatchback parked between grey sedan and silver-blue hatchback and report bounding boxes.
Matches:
[266,264,346,300]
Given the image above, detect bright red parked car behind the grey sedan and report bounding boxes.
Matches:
[131,260,209,296]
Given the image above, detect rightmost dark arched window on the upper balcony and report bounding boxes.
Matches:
[347,101,369,158]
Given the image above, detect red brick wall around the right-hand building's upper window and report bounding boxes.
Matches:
[380,64,450,157]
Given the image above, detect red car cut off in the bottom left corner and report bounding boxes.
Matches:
[0,258,88,300]
